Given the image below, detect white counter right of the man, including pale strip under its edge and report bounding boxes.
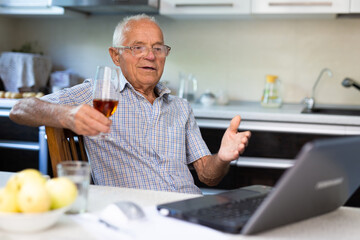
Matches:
[192,102,360,135]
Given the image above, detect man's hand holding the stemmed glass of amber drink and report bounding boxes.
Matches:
[63,104,111,136]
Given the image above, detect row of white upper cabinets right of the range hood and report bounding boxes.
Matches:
[160,0,352,18]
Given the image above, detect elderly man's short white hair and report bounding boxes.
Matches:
[113,13,157,47]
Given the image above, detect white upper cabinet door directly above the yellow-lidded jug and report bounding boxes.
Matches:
[252,0,350,14]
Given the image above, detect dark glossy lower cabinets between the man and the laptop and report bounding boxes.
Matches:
[196,124,344,189]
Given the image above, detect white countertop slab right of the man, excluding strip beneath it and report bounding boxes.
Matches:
[192,101,360,126]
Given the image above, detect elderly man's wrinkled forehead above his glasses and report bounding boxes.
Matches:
[123,20,164,45]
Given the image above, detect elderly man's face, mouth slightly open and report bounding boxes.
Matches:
[113,20,165,89]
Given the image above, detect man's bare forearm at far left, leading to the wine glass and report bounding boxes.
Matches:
[9,98,69,127]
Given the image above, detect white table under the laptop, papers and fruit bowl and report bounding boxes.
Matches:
[0,172,360,240]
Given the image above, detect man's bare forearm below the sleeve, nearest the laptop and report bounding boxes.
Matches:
[194,154,229,186]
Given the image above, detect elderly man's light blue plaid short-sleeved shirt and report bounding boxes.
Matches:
[42,72,210,194]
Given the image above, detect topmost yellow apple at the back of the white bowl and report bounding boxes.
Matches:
[6,168,46,191]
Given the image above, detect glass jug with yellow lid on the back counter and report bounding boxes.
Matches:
[261,75,282,107]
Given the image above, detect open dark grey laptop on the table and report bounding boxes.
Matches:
[157,137,360,235]
